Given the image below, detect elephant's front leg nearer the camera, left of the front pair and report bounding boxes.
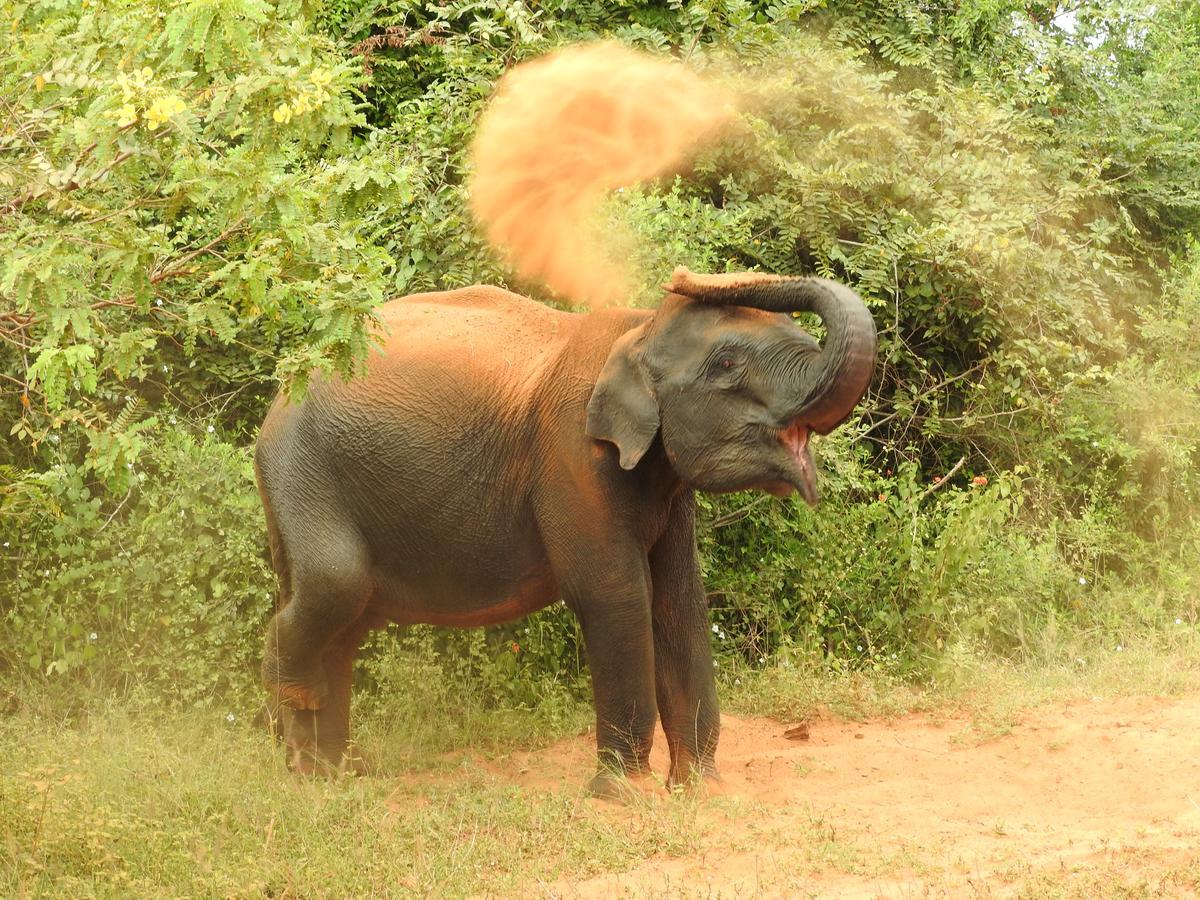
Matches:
[568,573,658,798]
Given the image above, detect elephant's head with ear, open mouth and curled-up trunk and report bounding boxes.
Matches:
[587,266,875,504]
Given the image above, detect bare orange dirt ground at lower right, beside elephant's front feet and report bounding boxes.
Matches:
[468,695,1200,898]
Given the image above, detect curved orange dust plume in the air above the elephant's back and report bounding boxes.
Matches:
[470,42,733,305]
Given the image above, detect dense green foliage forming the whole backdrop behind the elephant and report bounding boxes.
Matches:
[0,0,1200,708]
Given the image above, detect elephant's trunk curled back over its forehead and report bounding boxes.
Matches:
[664,266,875,434]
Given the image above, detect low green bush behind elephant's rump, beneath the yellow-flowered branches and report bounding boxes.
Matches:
[0,427,275,704]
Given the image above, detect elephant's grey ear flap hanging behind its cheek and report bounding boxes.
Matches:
[587,328,659,469]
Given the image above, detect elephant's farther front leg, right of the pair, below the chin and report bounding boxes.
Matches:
[650,493,721,786]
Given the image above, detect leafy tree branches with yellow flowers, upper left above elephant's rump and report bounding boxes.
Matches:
[0,0,408,458]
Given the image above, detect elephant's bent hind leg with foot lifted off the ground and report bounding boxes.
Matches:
[263,532,371,712]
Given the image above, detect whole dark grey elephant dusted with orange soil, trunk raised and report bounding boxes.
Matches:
[254,266,876,796]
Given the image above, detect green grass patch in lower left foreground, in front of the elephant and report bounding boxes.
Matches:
[0,707,694,896]
